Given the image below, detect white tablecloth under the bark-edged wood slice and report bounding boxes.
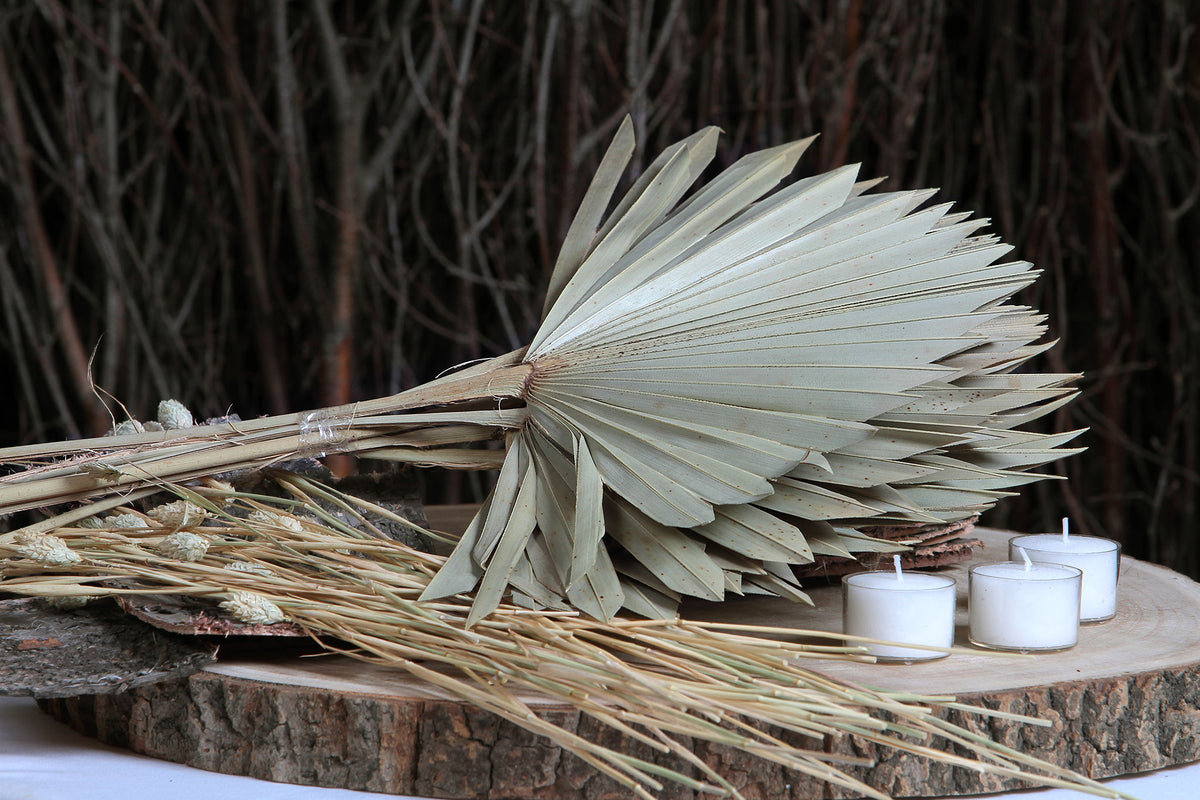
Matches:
[0,697,1200,800]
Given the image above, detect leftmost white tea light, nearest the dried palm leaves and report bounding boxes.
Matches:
[841,555,954,663]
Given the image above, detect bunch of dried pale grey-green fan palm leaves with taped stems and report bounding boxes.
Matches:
[0,120,1078,625]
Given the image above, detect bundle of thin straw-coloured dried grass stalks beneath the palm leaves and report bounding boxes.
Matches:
[0,471,1120,798]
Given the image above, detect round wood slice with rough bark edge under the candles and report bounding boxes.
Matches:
[35,525,1200,800]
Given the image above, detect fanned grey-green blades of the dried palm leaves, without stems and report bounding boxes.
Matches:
[426,123,1073,613]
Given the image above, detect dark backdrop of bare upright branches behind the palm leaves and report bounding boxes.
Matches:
[0,0,1200,576]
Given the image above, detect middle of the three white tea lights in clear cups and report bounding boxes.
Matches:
[967,561,1081,650]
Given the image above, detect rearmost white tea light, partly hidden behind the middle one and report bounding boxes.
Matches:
[1008,517,1121,622]
